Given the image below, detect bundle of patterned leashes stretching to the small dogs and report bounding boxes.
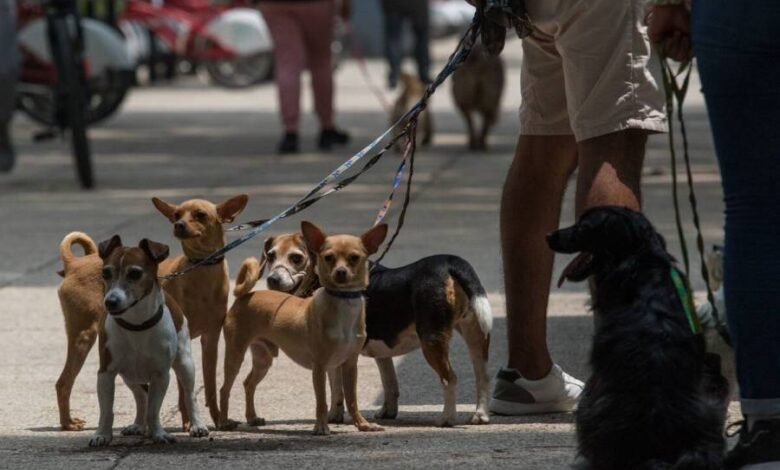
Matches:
[160,14,481,280]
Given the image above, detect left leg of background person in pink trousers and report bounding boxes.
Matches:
[260,2,306,154]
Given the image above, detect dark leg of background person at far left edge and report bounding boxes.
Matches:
[0,0,19,172]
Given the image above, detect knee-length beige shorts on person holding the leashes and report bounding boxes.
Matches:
[520,0,667,142]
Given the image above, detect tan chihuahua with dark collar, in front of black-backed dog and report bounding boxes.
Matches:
[220,222,387,435]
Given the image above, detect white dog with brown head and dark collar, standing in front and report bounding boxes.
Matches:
[89,235,209,446]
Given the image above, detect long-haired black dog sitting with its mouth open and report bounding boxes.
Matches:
[547,207,728,470]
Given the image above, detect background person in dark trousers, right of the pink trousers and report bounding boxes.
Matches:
[382,0,431,90]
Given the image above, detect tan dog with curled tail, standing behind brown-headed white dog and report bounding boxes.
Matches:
[56,195,248,431]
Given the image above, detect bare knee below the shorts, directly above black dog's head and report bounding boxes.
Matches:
[576,129,647,216]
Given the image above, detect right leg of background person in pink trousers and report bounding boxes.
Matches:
[297,0,349,150]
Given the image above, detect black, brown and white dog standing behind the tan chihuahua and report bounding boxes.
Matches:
[234,233,492,426]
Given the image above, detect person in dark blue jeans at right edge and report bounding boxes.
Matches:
[648,0,780,469]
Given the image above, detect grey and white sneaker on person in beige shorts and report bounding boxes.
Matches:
[489,364,585,416]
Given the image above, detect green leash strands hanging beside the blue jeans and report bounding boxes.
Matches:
[657,51,731,345]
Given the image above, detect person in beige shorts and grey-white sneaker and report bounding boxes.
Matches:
[470,0,667,415]
